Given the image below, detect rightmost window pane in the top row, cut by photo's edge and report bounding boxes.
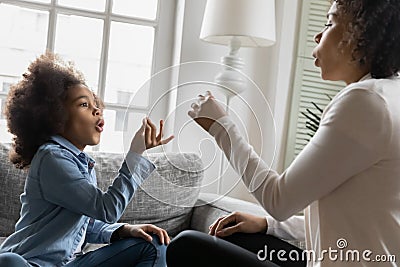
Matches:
[113,0,158,19]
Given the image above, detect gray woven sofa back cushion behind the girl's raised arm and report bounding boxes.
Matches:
[92,153,203,235]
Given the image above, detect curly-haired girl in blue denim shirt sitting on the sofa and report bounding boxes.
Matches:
[0,53,173,267]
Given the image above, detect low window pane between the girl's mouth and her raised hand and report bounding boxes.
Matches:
[100,109,146,153]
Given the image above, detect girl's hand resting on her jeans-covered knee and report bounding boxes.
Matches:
[118,224,171,245]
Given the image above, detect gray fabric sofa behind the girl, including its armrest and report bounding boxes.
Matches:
[0,143,266,250]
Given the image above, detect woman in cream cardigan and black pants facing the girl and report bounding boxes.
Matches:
[167,0,400,267]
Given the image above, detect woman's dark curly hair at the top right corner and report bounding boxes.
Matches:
[331,0,400,78]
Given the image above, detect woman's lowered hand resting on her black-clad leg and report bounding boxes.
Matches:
[209,212,268,237]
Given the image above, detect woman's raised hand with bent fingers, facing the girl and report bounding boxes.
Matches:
[188,91,227,132]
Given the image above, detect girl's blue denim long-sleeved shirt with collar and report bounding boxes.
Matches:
[0,136,155,266]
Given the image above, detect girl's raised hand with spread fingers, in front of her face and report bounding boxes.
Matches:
[130,118,174,154]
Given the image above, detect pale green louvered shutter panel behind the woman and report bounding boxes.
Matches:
[285,0,345,167]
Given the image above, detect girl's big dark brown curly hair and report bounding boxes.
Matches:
[5,52,85,169]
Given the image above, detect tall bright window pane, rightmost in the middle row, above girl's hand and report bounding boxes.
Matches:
[105,22,154,106]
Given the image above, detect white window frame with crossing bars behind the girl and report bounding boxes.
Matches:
[0,0,176,150]
